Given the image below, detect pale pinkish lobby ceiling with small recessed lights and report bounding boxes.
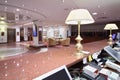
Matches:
[0,0,120,25]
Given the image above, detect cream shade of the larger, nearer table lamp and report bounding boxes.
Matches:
[65,9,94,24]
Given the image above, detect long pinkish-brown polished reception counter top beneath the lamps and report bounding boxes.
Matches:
[0,40,107,80]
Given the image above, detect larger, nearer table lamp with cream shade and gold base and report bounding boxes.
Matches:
[65,9,94,55]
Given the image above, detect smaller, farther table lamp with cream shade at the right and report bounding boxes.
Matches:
[104,23,118,46]
